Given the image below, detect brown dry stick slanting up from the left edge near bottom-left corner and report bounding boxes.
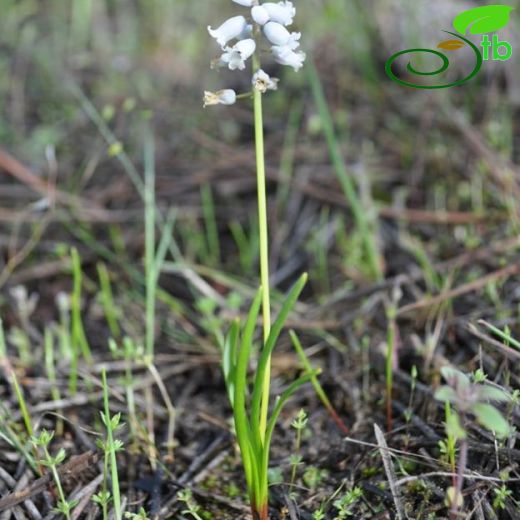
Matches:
[0,451,100,511]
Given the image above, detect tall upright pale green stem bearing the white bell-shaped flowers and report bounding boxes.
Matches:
[253,54,271,442]
